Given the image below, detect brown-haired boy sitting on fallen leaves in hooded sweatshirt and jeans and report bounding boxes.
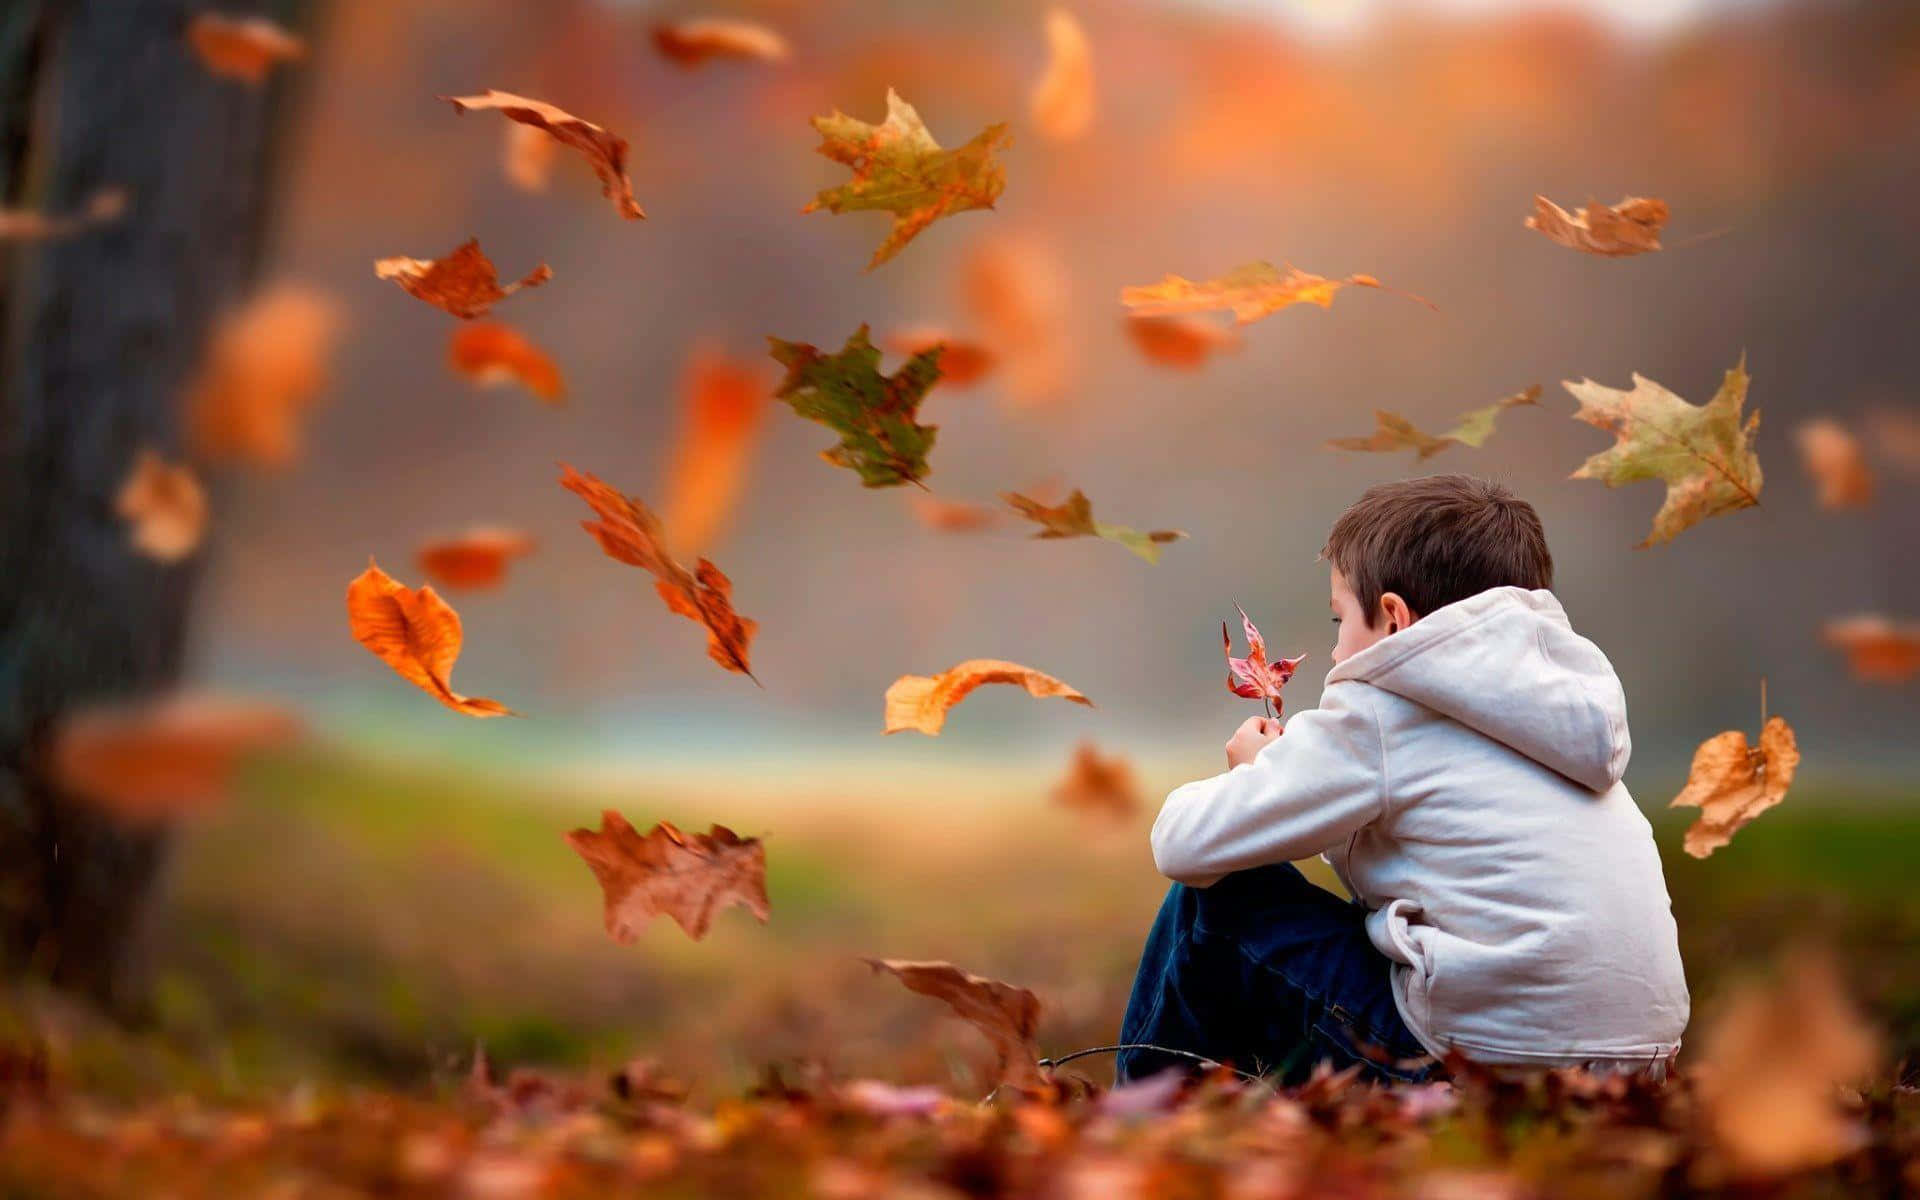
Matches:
[1119,474,1688,1081]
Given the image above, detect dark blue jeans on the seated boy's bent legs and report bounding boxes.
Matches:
[1116,862,1440,1083]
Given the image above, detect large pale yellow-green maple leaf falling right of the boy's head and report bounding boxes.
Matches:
[1561,355,1761,545]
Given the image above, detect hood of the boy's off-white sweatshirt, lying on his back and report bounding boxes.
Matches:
[1327,588,1632,791]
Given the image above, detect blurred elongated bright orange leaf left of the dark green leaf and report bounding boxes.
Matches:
[660,346,774,555]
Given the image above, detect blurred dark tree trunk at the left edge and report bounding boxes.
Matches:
[0,0,291,1014]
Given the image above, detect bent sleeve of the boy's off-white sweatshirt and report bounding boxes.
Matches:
[1152,682,1386,887]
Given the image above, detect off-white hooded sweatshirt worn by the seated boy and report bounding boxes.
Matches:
[1154,588,1688,1071]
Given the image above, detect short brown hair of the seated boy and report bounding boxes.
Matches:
[1321,474,1553,628]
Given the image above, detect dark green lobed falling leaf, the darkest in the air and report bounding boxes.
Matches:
[766,324,941,488]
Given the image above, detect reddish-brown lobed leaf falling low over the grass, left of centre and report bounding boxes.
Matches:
[566,808,772,945]
